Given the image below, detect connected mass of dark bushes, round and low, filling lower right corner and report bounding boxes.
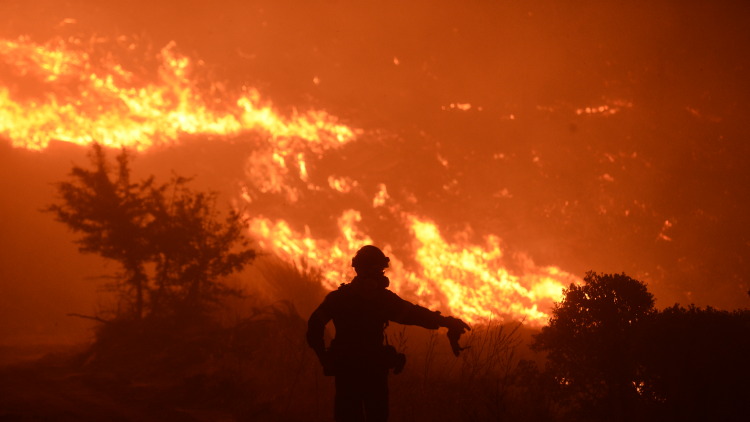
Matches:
[536,272,750,421]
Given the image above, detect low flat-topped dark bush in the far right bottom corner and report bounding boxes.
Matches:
[640,305,750,421]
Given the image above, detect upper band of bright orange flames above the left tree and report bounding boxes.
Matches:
[0,37,355,152]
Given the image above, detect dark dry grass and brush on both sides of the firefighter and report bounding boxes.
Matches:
[1,262,560,422]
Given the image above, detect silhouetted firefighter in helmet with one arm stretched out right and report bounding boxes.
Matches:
[307,245,471,422]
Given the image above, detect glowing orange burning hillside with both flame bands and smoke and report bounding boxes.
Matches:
[0,1,750,340]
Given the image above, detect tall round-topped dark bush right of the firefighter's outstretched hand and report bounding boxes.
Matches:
[534,272,654,420]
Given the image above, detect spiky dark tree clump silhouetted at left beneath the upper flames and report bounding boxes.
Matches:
[47,144,255,319]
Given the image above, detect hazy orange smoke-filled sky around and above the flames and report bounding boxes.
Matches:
[0,0,750,343]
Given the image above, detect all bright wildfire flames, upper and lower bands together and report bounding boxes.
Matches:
[0,38,577,325]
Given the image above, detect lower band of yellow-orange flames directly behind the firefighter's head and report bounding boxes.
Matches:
[250,210,578,326]
